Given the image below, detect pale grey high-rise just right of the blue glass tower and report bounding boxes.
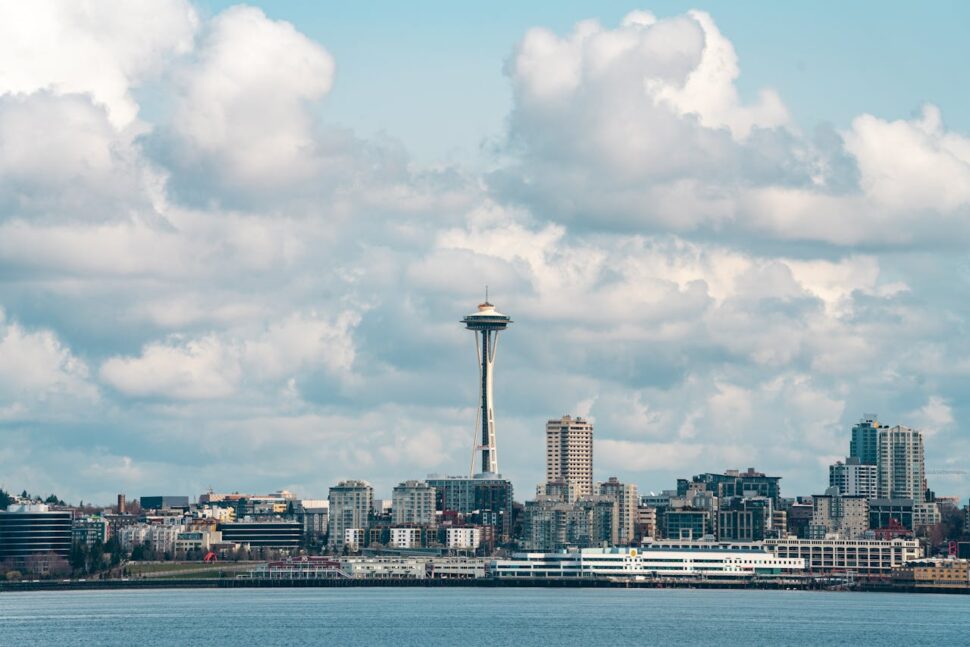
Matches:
[876,425,926,504]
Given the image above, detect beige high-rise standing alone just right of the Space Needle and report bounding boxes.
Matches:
[546,416,593,496]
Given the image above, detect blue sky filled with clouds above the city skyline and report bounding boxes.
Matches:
[0,1,970,502]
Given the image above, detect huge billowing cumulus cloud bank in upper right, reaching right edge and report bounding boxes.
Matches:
[489,11,970,246]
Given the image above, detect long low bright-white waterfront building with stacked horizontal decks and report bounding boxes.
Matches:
[492,541,805,578]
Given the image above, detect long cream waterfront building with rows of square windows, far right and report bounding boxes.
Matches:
[765,537,923,576]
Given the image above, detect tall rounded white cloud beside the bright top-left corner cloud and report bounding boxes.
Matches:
[172,6,334,187]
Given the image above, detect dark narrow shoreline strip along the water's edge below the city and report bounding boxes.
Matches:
[0,578,970,595]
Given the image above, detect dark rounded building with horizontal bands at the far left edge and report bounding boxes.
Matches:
[0,503,71,562]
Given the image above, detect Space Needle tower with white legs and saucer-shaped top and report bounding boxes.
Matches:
[461,289,512,474]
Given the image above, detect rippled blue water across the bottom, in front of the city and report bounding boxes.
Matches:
[0,588,970,647]
